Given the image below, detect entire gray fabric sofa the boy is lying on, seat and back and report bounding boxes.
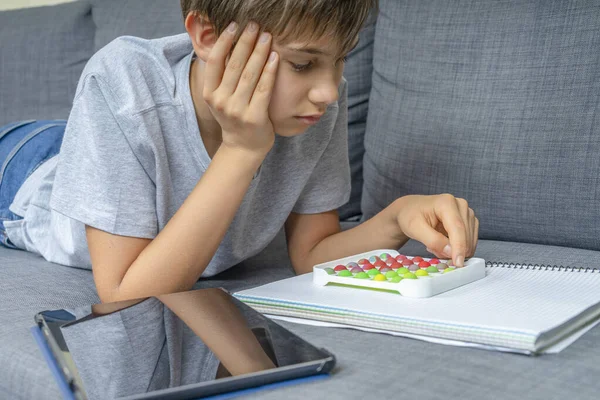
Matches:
[0,0,600,400]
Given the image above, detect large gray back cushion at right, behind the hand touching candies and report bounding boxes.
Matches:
[362,0,600,250]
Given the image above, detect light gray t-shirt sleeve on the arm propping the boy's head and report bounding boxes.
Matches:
[50,75,158,238]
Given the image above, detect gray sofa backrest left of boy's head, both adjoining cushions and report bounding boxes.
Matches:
[0,0,185,126]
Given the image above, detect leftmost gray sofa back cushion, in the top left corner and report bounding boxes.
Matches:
[0,0,95,126]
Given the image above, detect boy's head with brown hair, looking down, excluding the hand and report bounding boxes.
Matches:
[181,0,378,136]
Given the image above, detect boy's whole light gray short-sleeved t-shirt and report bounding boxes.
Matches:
[6,34,350,277]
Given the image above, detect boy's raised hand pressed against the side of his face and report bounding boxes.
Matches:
[203,22,279,154]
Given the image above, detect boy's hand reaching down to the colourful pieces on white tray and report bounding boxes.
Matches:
[391,194,479,266]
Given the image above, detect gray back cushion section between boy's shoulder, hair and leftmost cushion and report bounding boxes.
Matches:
[91,0,185,51]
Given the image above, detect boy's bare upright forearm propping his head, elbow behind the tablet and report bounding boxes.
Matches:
[117,146,264,299]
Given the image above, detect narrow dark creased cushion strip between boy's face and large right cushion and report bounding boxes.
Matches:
[338,8,377,221]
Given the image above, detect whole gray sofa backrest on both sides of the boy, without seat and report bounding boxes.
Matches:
[5,0,600,250]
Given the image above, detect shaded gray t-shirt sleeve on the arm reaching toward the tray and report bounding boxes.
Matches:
[292,80,350,214]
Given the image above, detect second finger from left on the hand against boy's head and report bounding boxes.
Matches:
[219,22,258,95]
